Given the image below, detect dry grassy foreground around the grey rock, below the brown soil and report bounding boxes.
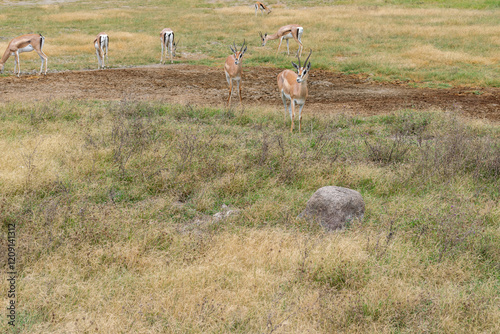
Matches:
[0,101,500,333]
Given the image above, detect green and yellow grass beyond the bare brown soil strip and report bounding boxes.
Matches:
[0,0,500,86]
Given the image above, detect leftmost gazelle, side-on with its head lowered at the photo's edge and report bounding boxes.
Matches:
[0,34,48,77]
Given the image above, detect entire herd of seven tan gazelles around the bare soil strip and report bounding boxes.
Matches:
[0,1,312,132]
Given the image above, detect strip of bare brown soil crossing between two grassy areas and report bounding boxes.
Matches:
[0,64,500,121]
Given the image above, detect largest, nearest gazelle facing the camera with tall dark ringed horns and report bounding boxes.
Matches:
[278,50,312,132]
